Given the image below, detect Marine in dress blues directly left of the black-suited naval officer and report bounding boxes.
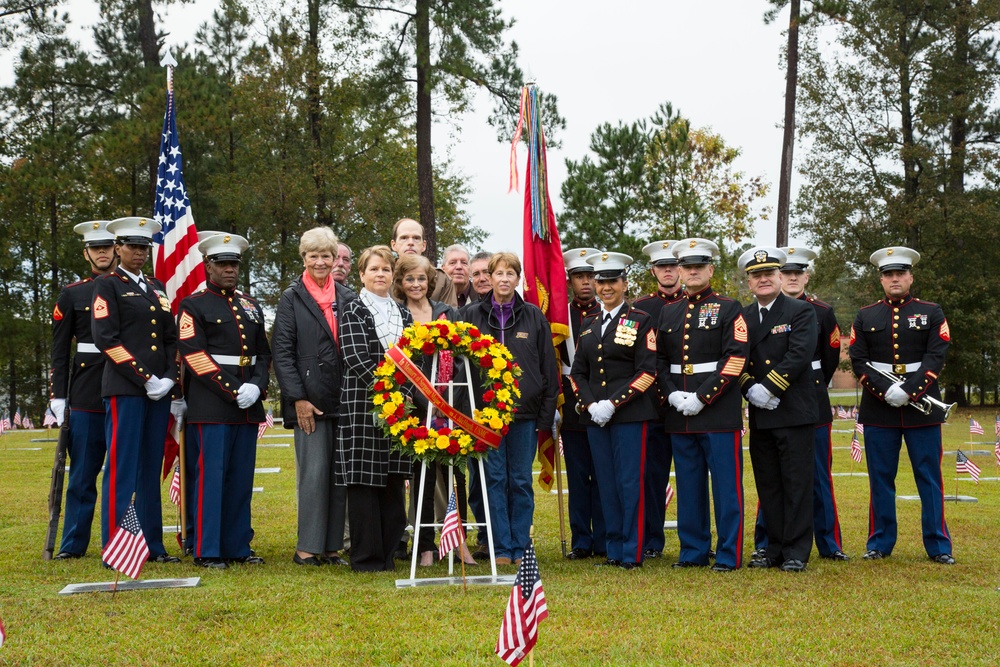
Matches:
[656,238,747,572]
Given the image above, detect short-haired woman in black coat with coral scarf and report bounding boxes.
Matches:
[271,227,354,565]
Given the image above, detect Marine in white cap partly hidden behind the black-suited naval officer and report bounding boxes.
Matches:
[754,247,850,561]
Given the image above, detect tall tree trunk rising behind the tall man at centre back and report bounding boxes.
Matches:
[416,0,437,264]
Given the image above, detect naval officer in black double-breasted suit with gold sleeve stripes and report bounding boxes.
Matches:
[739,248,817,572]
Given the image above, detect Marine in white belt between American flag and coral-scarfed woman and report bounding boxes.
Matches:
[177,234,271,569]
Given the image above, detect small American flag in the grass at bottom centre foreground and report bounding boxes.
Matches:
[496,542,549,667]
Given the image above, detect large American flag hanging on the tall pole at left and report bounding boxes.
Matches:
[153,67,205,315]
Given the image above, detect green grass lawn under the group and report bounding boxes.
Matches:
[0,411,1000,667]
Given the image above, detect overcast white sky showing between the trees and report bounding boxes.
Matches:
[17,0,799,252]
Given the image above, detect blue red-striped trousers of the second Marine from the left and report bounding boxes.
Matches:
[101,396,170,558]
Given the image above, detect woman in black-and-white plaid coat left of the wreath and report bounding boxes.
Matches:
[337,246,413,572]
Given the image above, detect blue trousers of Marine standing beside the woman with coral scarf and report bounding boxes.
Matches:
[187,424,257,558]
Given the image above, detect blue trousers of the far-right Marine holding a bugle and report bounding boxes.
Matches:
[865,424,951,558]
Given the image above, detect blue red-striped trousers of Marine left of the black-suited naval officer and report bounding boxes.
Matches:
[670,431,743,568]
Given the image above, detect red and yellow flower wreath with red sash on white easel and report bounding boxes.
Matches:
[372,319,521,470]
